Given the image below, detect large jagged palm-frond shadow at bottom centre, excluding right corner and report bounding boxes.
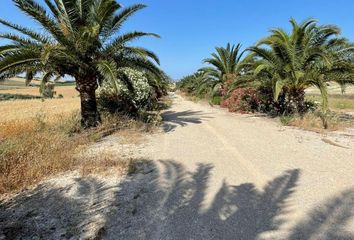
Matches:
[106,161,300,239]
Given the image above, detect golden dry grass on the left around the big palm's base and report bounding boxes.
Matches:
[0,107,145,194]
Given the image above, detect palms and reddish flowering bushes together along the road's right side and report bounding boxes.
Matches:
[177,19,354,129]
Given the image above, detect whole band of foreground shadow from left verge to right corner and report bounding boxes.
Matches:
[0,160,354,240]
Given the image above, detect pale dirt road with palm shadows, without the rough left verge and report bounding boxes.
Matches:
[120,93,354,239]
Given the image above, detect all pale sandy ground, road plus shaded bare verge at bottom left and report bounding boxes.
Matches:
[0,95,354,240]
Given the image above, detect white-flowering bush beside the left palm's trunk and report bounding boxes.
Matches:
[98,68,153,112]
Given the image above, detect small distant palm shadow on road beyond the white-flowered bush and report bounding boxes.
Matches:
[161,110,212,132]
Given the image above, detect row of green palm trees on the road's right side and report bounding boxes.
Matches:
[179,19,354,119]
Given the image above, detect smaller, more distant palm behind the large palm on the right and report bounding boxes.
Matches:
[200,43,244,94]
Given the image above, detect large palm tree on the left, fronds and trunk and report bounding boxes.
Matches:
[0,0,161,128]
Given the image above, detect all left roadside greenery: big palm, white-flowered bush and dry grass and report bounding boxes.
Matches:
[0,0,170,193]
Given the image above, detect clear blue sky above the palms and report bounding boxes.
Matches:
[0,0,354,79]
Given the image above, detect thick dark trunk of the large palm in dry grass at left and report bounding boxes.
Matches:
[76,77,101,128]
